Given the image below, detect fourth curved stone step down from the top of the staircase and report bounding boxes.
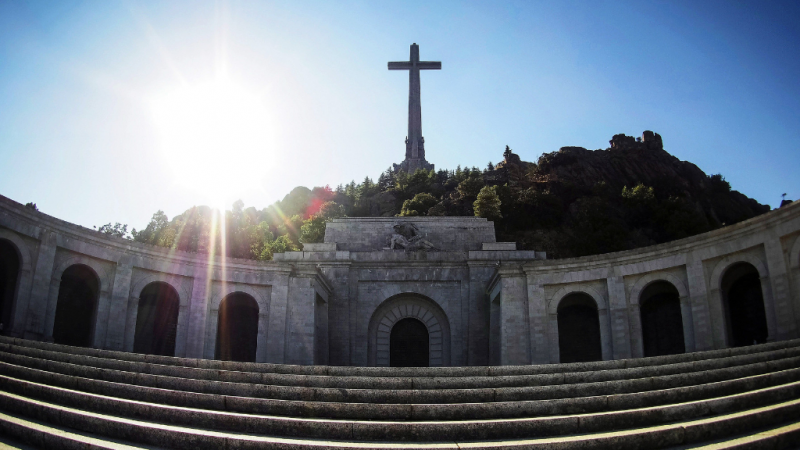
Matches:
[0,357,800,420]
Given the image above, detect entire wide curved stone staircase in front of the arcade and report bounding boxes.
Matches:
[0,337,800,450]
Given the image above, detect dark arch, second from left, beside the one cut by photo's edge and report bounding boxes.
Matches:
[53,264,100,347]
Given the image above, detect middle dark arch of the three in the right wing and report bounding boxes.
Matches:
[639,281,686,356]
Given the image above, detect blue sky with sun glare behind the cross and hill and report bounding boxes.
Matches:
[0,0,800,228]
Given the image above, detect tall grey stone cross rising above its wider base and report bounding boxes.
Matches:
[389,44,442,163]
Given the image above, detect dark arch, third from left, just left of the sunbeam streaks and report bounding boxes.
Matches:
[133,282,180,356]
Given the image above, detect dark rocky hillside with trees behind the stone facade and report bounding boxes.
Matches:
[100,132,769,260]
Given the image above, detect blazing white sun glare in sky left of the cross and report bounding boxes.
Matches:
[152,80,276,206]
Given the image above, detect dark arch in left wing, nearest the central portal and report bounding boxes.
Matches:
[214,292,258,362]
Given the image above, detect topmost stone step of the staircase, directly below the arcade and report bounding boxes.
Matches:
[0,336,800,379]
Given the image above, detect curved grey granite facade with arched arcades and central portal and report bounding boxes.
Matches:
[0,193,800,366]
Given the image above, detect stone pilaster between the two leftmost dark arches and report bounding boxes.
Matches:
[24,230,57,340]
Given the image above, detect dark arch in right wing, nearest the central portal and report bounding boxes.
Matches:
[558,294,603,363]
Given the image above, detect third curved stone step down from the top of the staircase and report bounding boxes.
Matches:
[0,342,800,407]
